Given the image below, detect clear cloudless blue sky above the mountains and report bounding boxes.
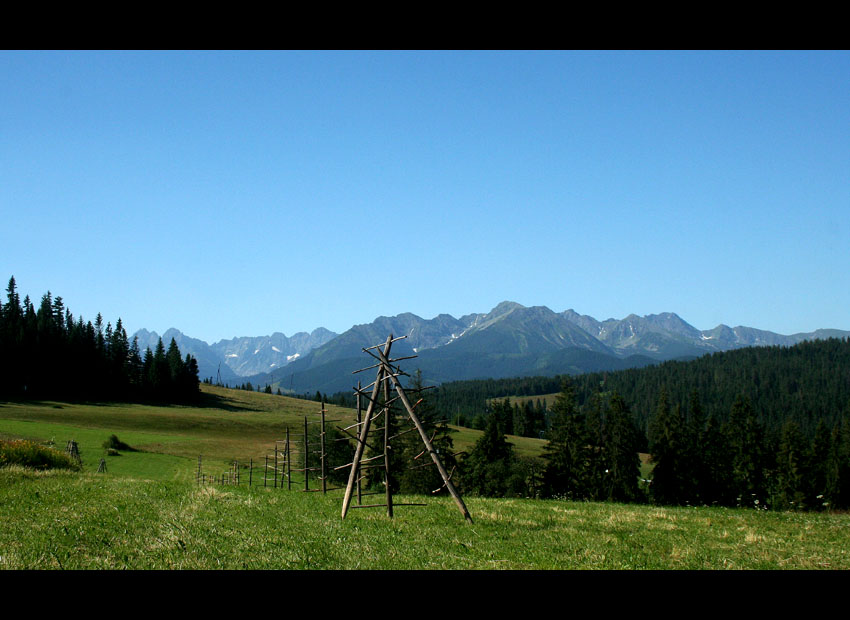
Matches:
[0,51,850,343]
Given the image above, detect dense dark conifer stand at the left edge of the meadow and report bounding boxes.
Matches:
[0,277,199,403]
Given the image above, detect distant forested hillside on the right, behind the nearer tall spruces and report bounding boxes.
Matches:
[434,338,850,437]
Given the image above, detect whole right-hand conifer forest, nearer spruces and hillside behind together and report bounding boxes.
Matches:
[437,339,850,510]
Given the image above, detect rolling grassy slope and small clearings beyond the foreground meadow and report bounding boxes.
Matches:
[0,385,545,480]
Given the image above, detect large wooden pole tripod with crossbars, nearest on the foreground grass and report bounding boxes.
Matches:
[342,334,472,523]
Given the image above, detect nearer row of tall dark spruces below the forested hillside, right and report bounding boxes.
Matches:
[460,379,850,510]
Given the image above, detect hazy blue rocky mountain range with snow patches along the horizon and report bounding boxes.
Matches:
[129,301,850,394]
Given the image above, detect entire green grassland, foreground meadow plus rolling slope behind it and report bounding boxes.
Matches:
[0,386,850,570]
